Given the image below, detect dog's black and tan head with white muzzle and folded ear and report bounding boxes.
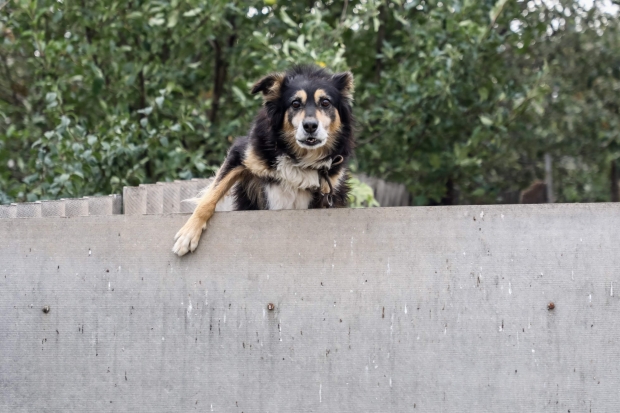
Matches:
[252,66,353,150]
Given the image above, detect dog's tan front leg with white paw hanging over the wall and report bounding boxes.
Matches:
[172,166,245,257]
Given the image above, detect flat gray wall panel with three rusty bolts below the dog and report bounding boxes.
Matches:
[0,204,620,413]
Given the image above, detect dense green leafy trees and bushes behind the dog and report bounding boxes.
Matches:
[0,0,620,204]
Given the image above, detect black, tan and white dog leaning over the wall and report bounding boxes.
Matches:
[172,66,355,256]
